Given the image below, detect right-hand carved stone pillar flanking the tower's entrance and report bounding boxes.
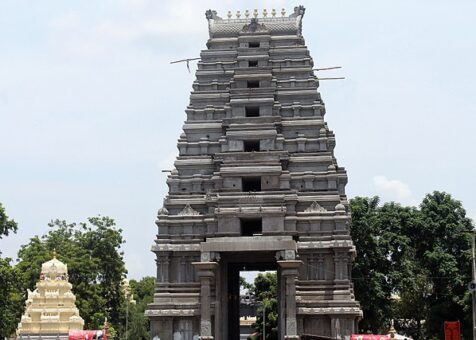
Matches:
[278,256,302,340]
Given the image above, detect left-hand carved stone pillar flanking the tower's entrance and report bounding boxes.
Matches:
[193,253,218,340]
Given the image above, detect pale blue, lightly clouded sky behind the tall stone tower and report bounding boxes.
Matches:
[0,0,476,278]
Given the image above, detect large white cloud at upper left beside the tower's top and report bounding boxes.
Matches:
[44,0,207,59]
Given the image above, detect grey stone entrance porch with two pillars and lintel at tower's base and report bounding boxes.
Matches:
[194,236,301,340]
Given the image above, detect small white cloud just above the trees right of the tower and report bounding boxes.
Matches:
[373,175,418,205]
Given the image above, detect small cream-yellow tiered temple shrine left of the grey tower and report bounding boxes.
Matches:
[17,254,84,339]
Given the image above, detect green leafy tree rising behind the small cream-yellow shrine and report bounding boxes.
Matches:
[16,217,126,331]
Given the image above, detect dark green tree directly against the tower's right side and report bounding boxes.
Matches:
[350,197,418,333]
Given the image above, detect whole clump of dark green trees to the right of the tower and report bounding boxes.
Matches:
[350,192,473,339]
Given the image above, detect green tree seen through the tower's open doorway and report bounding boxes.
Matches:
[250,272,278,340]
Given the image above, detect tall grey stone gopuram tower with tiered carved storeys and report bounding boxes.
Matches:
[146,6,362,340]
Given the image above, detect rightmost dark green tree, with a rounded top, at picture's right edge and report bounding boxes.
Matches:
[414,191,474,339]
